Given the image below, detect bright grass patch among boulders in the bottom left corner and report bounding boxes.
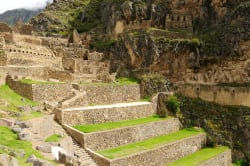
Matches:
[0,126,44,166]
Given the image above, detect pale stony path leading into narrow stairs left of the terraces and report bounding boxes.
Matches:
[24,115,97,166]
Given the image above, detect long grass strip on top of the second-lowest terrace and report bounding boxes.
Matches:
[98,128,203,159]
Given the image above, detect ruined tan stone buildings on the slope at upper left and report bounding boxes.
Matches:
[0,22,110,81]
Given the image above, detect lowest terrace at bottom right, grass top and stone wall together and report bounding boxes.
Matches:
[167,146,232,166]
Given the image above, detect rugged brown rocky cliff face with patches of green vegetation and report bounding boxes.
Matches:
[31,0,250,83]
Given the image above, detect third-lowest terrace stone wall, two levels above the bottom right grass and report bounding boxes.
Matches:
[62,118,180,151]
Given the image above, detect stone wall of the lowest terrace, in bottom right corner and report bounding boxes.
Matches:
[199,150,232,166]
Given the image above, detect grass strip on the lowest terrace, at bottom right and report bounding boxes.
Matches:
[167,146,228,166]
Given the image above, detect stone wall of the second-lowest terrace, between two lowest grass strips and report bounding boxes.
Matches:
[88,133,206,166]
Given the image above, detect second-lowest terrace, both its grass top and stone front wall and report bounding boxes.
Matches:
[90,130,206,166]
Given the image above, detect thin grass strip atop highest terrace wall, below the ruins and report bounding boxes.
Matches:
[81,78,139,86]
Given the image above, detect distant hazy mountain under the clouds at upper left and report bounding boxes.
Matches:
[0,9,42,25]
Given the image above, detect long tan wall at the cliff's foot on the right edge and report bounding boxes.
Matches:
[178,85,250,107]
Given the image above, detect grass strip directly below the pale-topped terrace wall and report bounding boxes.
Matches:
[73,115,167,133]
